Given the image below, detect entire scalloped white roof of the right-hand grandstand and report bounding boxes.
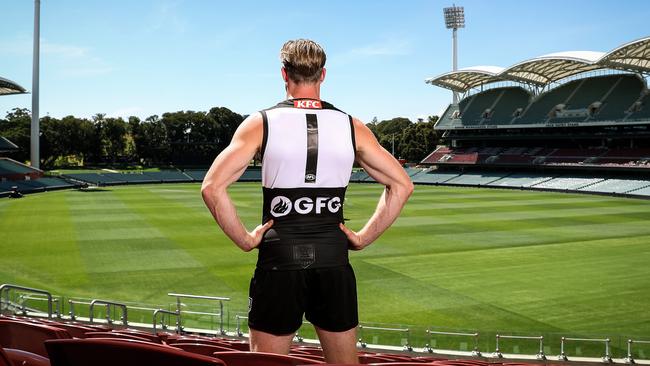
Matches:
[425,37,650,92]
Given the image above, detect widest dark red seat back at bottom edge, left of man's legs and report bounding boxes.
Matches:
[45,338,225,366]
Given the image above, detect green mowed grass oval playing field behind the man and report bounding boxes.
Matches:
[0,183,650,353]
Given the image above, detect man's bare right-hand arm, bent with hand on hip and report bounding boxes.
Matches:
[340,119,413,250]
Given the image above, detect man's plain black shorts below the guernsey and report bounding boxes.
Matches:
[248,264,359,335]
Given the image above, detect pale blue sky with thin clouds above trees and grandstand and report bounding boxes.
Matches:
[0,0,650,122]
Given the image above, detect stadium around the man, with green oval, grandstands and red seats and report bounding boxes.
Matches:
[0,2,650,366]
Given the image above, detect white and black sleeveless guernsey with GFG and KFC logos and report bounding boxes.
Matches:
[257,99,356,270]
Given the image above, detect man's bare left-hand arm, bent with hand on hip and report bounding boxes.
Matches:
[201,113,273,252]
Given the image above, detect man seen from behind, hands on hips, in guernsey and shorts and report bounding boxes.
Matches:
[201,39,413,363]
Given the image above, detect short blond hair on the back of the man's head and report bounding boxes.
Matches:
[280,39,327,83]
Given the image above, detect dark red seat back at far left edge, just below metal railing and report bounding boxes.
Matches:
[0,320,72,357]
